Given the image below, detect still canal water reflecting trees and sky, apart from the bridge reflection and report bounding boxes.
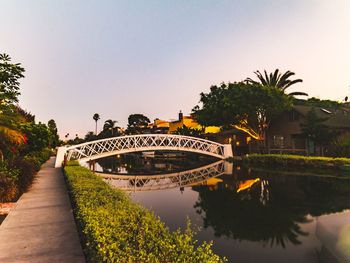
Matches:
[95,155,350,263]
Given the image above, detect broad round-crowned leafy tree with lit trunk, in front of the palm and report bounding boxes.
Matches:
[192,82,291,140]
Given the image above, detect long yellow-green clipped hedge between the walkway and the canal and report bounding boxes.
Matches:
[64,163,224,262]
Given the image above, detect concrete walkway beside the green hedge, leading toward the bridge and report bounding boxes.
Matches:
[0,158,85,262]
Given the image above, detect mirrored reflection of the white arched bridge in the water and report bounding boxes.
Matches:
[95,161,232,192]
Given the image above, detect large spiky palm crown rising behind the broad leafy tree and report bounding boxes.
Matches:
[245,69,308,96]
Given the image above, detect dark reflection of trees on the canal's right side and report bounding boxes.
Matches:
[194,174,350,250]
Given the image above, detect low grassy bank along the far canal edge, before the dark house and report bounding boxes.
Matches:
[242,154,350,171]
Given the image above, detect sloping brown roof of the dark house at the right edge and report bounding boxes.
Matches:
[293,105,350,128]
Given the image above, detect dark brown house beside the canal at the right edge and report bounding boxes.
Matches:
[266,105,350,155]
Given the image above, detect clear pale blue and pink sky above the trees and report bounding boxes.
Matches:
[0,0,350,137]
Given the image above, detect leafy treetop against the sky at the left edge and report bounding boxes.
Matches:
[0,54,25,105]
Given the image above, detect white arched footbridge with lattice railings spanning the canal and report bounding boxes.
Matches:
[55,134,233,167]
